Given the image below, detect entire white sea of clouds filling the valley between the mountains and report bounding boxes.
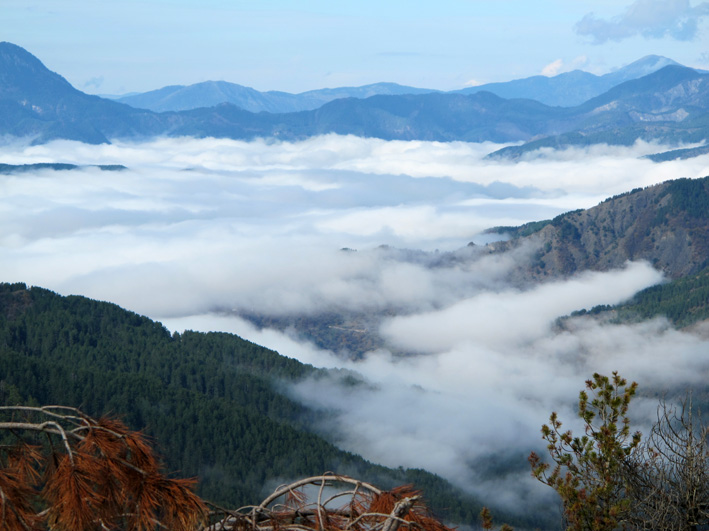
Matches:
[0,135,709,504]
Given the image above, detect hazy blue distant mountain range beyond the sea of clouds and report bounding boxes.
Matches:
[0,43,709,158]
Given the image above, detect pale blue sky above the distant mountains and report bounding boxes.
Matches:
[0,0,709,94]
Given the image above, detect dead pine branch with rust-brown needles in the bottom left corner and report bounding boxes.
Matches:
[0,406,207,531]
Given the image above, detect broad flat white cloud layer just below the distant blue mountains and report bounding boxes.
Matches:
[0,135,709,317]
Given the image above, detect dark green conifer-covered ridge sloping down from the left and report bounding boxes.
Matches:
[0,284,504,522]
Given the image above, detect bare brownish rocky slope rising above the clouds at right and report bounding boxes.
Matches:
[490,177,709,280]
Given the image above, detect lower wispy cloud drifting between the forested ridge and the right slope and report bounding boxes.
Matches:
[284,264,709,509]
